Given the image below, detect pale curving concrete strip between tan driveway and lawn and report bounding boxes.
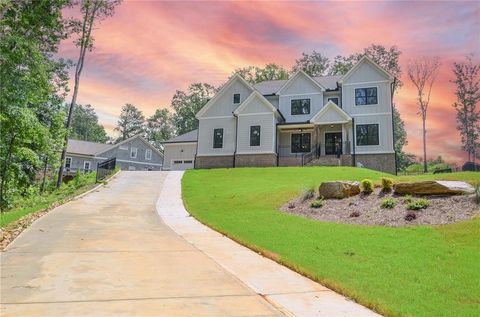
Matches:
[156,171,380,317]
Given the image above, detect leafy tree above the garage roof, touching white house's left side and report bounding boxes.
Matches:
[171,83,217,135]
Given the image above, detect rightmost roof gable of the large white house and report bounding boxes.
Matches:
[338,55,393,84]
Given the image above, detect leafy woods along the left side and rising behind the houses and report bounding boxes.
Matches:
[0,0,480,209]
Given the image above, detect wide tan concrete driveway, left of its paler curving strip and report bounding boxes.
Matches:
[0,172,281,316]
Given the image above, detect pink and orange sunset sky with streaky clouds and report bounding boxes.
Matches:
[59,1,480,162]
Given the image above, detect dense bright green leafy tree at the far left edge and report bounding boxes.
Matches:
[0,0,68,210]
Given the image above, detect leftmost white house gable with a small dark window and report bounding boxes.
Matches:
[195,74,254,119]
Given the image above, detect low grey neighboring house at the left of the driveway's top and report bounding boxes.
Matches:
[65,135,163,174]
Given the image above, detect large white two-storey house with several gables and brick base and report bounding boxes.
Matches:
[165,57,396,173]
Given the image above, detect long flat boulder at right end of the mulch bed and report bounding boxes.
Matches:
[393,181,475,195]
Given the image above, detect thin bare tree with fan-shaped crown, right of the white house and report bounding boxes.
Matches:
[408,57,440,173]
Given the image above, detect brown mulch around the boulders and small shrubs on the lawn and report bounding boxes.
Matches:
[280,188,480,227]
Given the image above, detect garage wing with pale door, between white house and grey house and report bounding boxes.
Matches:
[163,130,198,171]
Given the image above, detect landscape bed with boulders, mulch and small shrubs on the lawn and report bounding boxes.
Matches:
[280,180,480,227]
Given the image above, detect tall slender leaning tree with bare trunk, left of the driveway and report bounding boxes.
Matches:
[57,0,121,187]
